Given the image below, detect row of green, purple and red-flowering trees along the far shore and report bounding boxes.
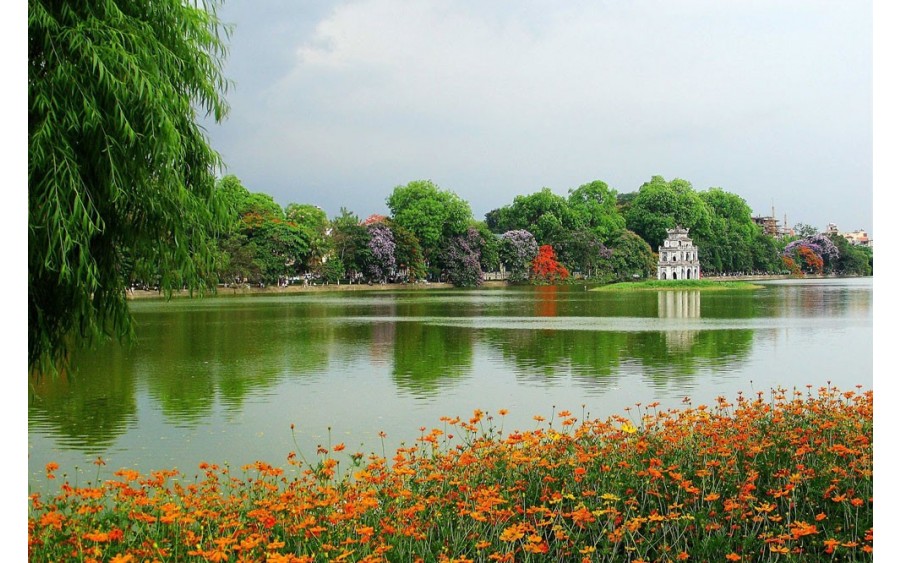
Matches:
[203,176,871,287]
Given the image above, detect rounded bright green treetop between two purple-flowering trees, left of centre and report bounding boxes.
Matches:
[386,180,473,260]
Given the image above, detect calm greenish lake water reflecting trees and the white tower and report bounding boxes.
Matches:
[28,278,873,491]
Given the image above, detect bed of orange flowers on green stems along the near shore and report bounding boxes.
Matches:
[28,388,872,562]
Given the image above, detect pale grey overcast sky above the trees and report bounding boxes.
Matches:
[201,0,872,233]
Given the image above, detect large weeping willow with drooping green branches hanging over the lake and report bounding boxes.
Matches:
[28,0,229,371]
